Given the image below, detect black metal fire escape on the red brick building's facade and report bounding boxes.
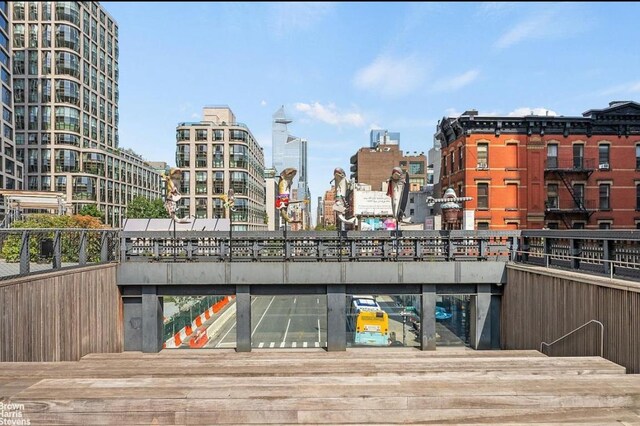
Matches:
[544,156,596,229]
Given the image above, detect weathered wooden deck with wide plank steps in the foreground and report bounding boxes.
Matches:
[0,348,640,425]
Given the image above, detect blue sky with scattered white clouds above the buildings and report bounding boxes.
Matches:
[103,2,640,223]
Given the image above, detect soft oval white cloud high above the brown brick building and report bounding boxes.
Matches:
[354,56,426,96]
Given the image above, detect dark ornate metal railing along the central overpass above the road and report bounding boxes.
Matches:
[120,231,518,262]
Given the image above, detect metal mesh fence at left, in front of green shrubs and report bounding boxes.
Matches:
[0,228,120,280]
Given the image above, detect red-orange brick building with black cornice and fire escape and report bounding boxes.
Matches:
[436,101,640,230]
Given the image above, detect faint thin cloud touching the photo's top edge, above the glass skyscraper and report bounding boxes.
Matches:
[270,2,335,35]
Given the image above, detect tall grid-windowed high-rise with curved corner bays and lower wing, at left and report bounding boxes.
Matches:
[9,1,161,226]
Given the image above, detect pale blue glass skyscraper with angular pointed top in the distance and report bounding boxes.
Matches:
[272,106,311,229]
